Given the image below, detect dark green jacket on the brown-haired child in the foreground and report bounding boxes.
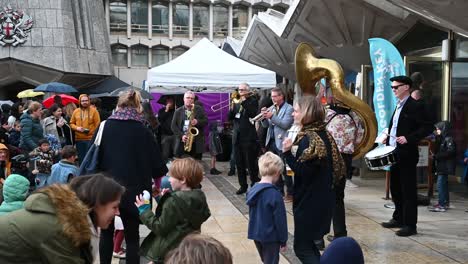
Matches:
[140,190,211,262]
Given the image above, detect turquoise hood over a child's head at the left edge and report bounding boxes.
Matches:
[3,174,29,203]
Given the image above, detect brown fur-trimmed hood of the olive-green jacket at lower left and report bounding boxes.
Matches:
[24,184,91,247]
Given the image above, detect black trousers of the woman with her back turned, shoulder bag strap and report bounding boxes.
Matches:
[99,202,140,264]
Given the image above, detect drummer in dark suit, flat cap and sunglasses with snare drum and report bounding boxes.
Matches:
[382,76,432,236]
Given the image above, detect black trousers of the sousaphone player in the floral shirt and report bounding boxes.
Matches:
[333,153,353,237]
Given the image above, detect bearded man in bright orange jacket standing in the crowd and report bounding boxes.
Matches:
[70,94,101,162]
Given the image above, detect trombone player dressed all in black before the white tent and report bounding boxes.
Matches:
[229,83,260,194]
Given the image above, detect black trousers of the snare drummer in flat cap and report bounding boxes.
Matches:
[390,157,418,228]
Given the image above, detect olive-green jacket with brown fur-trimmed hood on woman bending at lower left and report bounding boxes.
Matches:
[0,185,92,264]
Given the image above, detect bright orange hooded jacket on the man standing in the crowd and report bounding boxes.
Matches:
[70,94,101,141]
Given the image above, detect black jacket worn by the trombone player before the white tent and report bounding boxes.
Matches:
[229,96,258,144]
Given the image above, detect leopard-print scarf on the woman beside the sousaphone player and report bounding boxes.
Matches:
[294,121,346,186]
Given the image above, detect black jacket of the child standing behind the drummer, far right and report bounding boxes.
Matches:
[434,121,456,175]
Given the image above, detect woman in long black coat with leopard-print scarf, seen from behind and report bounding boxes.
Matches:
[283,96,345,264]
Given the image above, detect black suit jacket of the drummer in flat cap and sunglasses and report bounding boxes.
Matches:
[387,96,433,163]
